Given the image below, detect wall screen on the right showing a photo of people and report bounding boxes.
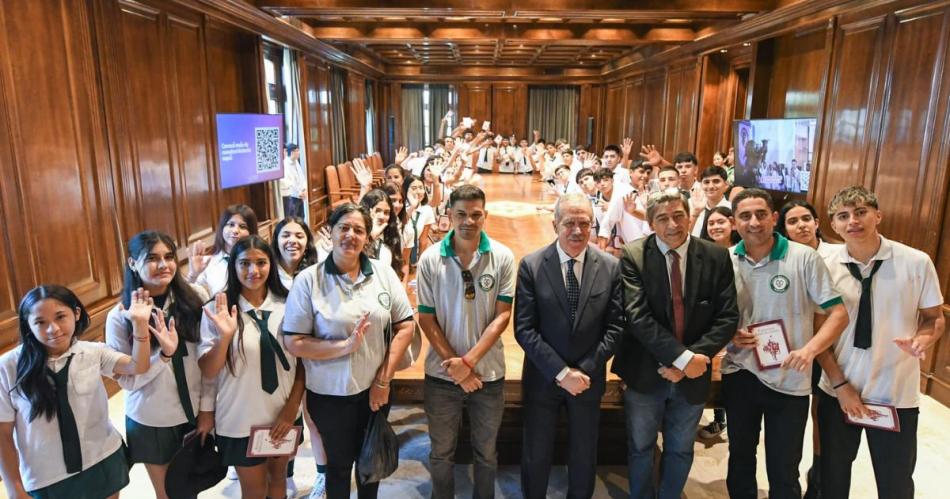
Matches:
[732,118,817,193]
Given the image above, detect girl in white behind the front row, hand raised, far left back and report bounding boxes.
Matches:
[188,204,257,296]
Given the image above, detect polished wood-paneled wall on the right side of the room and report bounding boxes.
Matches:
[603,0,950,405]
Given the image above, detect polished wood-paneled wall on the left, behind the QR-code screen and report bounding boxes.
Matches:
[0,0,365,351]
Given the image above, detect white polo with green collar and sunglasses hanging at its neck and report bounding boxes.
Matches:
[416,230,516,381]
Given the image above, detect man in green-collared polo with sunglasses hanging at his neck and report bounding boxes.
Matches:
[416,186,516,499]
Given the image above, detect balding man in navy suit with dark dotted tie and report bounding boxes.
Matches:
[515,194,624,499]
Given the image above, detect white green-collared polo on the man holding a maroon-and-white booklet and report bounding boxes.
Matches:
[722,233,842,395]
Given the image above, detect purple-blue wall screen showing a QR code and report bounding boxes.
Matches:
[216,114,284,189]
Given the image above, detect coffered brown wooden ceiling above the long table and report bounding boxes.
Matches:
[256,0,780,70]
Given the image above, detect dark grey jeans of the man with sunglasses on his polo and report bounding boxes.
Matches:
[423,376,505,499]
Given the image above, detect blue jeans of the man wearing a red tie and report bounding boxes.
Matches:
[623,381,703,499]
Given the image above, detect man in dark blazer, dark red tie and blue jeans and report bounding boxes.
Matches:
[613,189,739,499]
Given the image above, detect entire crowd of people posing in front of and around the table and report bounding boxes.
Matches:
[0,119,944,498]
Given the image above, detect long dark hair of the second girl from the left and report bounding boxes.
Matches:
[120,230,201,346]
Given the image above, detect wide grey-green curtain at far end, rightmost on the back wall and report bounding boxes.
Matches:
[528,85,578,145]
